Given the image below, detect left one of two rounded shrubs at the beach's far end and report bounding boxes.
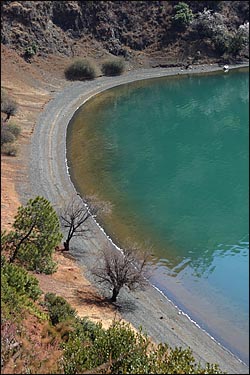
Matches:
[64,59,96,81]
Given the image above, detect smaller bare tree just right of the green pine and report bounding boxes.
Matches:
[60,196,97,251]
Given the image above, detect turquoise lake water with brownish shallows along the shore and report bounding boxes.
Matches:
[67,70,249,363]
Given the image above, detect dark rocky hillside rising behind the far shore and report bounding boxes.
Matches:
[1,1,249,66]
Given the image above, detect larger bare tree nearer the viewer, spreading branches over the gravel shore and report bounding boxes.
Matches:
[92,247,149,302]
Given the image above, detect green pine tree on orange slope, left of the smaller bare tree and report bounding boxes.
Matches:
[3,196,62,273]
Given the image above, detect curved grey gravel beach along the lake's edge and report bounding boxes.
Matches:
[27,65,249,374]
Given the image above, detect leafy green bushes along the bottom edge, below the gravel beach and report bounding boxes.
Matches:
[62,320,224,374]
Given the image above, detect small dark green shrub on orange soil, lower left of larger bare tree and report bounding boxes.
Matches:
[44,293,76,325]
